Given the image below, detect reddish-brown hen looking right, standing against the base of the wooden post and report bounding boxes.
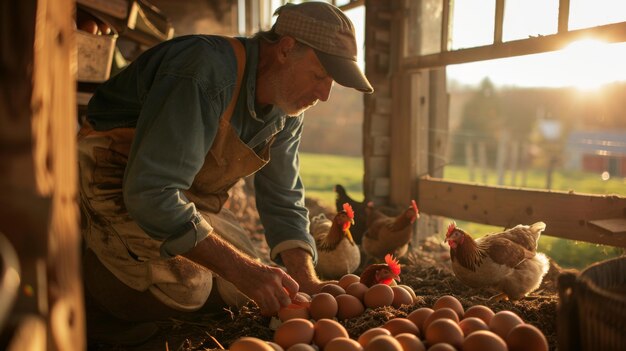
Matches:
[361,200,419,260]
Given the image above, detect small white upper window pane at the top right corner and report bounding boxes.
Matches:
[569,0,626,30]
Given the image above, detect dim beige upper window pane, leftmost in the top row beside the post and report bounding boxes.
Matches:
[405,0,443,56]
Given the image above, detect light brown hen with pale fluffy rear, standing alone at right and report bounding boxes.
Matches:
[446,222,550,301]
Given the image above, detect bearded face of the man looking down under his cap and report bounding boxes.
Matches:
[272,47,333,116]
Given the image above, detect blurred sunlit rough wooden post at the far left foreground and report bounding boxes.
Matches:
[0,0,86,350]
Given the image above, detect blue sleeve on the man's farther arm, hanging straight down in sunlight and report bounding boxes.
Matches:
[255,115,317,263]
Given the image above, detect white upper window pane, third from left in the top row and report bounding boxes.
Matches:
[502,0,559,41]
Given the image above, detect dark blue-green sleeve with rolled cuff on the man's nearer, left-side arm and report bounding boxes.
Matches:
[124,74,219,257]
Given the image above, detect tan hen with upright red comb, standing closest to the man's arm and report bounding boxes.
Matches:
[311,203,361,279]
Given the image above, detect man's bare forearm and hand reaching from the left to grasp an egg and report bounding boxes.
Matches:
[184,235,299,316]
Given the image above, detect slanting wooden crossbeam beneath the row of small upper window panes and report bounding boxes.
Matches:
[402,22,626,70]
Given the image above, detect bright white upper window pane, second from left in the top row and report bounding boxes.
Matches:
[451,0,496,50]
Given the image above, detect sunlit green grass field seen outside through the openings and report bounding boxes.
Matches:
[300,153,626,269]
